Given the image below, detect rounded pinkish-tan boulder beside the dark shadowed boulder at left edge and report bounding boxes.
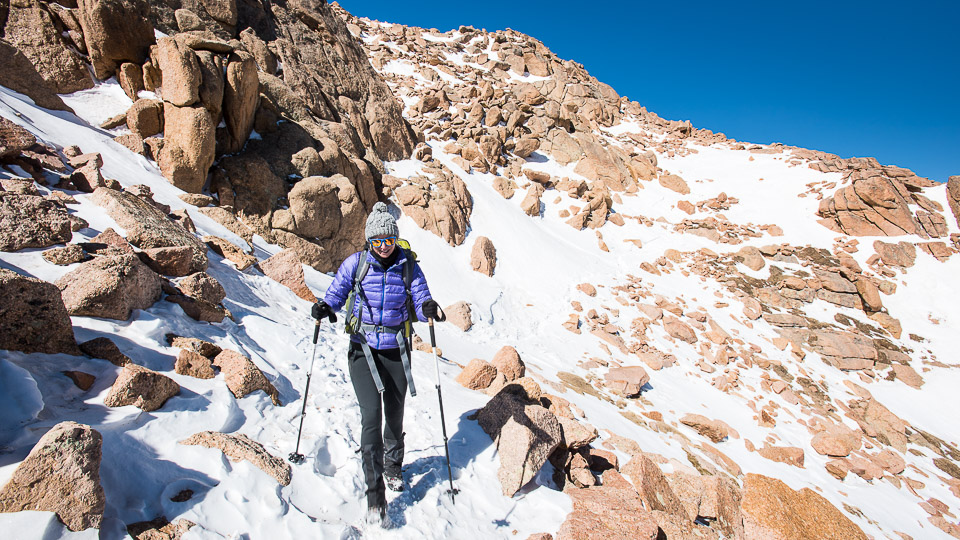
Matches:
[55,255,161,321]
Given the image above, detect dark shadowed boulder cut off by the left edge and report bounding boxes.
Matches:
[0,268,80,355]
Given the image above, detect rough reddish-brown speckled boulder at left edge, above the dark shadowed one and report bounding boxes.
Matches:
[0,191,73,251]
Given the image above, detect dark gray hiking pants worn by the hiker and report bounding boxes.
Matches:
[347,342,407,507]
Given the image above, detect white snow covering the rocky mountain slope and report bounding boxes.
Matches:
[0,37,960,539]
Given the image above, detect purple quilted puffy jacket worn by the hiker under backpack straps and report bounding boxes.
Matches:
[323,247,431,349]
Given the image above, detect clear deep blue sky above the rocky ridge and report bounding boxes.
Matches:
[340,0,960,182]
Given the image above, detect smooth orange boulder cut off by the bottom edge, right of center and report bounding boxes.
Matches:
[741,473,867,540]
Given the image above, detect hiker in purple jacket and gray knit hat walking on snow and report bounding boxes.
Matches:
[312,202,439,522]
